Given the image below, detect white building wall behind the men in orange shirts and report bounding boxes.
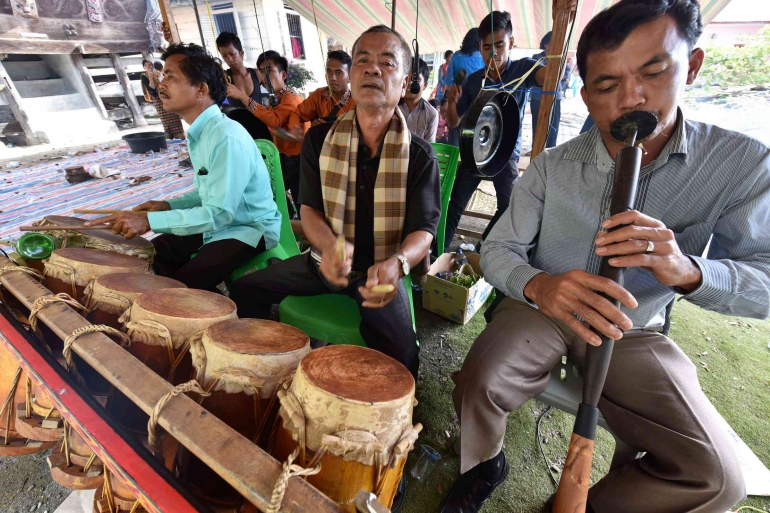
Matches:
[172,0,326,91]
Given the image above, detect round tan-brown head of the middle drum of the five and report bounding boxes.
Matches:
[134,289,236,319]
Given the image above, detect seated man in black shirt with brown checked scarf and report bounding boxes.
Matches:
[230,25,441,377]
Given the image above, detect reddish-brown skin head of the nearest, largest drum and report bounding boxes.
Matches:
[300,345,414,403]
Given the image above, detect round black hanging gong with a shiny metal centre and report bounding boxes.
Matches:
[460,89,519,178]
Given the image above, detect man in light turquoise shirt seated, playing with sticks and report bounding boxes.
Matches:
[88,44,281,290]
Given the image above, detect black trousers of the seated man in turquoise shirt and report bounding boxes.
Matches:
[152,234,265,292]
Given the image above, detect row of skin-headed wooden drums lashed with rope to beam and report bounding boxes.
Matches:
[0,243,420,513]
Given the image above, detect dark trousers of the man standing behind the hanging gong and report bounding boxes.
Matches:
[444,161,519,248]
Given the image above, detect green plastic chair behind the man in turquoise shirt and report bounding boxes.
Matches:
[230,139,299,282]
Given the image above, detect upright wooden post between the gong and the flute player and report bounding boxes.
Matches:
[532,0,570,159]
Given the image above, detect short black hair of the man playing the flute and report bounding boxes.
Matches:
[577,0,703,82]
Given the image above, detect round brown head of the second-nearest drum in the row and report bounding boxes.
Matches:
[206,319,310,354]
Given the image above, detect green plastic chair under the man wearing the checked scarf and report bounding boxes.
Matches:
[278,143,452,346]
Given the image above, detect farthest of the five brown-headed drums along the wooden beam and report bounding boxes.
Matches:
[44,248,149,301]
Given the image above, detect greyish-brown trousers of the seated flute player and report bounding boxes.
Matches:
[452,298,745,513]
